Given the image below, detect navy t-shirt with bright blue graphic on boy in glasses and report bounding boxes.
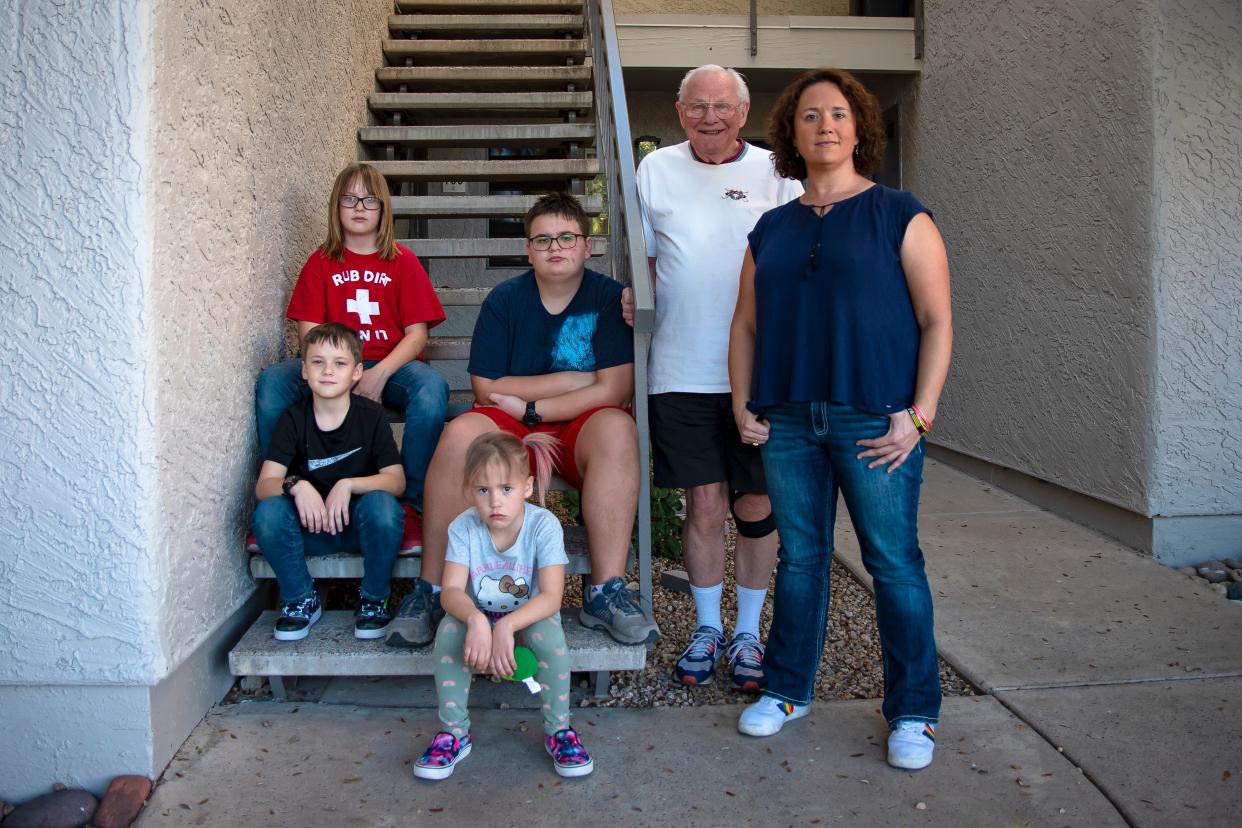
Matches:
[468,271,633,380]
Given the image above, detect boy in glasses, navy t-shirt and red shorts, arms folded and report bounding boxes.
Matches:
[388,192,660,647]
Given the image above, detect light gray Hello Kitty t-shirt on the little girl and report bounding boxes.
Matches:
[445,503,569,621]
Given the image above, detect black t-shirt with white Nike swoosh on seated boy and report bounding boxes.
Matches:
[266,394,401,498]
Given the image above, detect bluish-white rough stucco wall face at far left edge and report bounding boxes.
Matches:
[0,0,164,685]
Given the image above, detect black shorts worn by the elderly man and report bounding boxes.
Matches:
[647,391,768,494]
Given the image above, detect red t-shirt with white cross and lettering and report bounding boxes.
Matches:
[286,245,445,360]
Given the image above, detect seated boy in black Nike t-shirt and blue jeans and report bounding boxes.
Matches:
[253,323,405,641]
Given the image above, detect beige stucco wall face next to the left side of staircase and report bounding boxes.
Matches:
[150,0,391,664]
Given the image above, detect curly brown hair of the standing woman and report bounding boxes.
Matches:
[768,68,887,181]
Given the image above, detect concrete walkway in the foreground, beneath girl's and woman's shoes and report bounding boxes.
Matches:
[139,463,1242,827]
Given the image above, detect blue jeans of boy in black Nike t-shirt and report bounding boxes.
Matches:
[252,492,405,602]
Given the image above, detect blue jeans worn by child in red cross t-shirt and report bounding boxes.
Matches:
[255,359,448,511]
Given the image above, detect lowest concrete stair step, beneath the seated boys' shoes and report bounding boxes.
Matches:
[229,607,647,691]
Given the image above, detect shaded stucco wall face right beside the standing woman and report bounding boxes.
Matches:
[903,0,1155,514]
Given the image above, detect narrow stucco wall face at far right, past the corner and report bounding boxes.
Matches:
[1151,0,1242,513]
